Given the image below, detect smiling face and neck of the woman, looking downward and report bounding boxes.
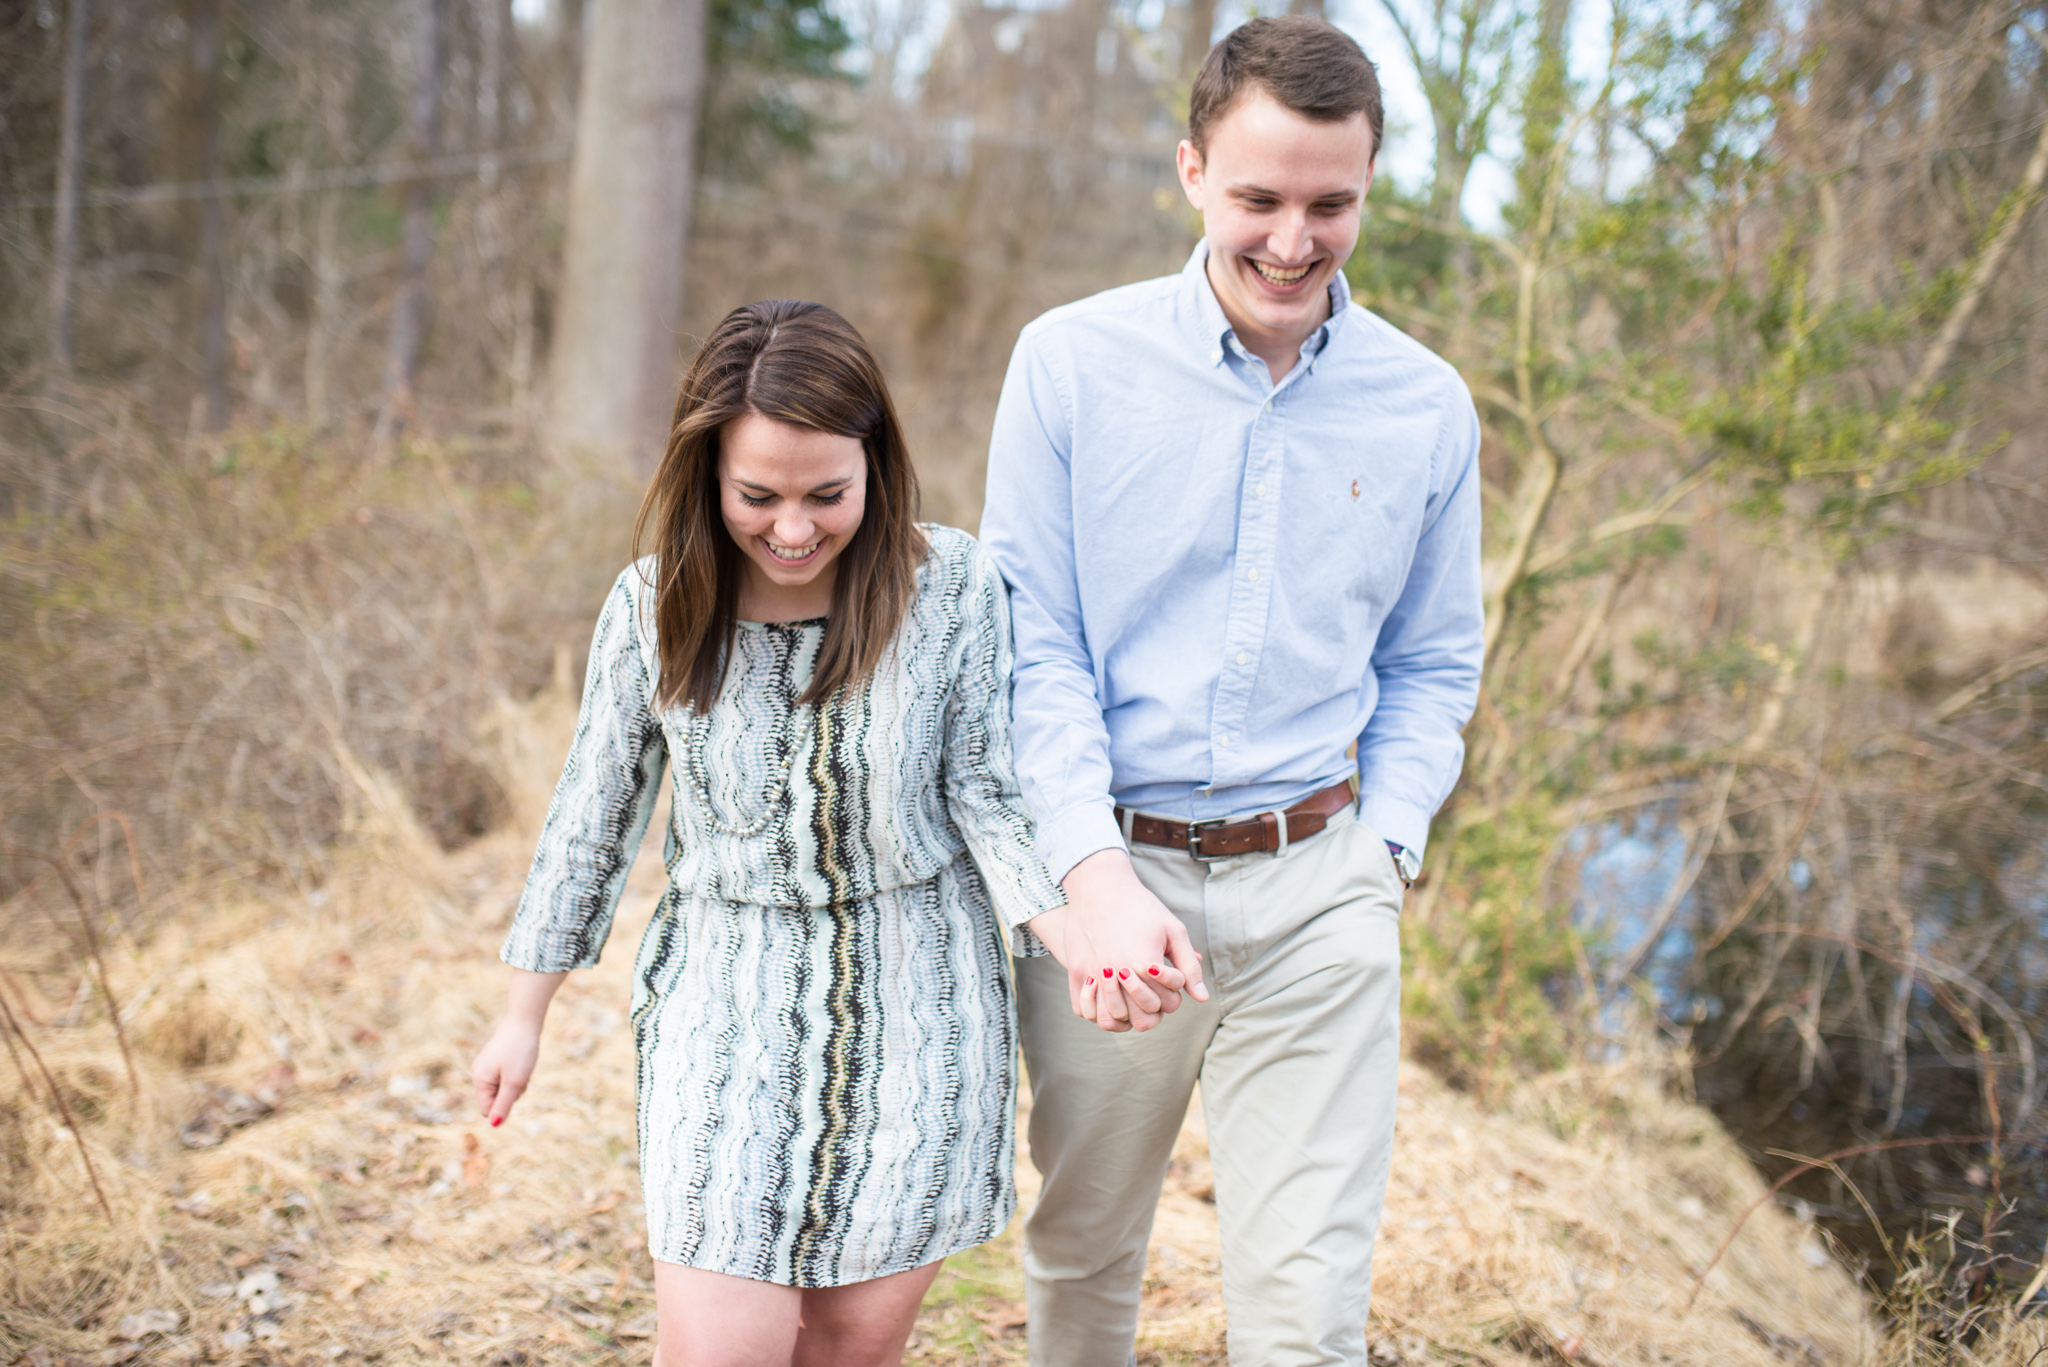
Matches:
[719,414,868,615]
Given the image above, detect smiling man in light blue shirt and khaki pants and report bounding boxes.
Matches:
[983,18,1483,1367]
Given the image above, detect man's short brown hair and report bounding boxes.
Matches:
[1188,14,1386,156]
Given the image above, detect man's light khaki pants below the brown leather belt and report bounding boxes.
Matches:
[1018,810,1401,1367]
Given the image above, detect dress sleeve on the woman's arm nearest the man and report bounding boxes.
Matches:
[944,545,1067,957]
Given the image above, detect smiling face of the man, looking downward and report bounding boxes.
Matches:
[1180,86,1374,348]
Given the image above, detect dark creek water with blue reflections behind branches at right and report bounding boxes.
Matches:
[1565,807,2048,1287]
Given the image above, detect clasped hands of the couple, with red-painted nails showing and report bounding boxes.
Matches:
[1030,848,1208,1033]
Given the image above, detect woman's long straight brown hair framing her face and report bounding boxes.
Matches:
[633,299,926,711]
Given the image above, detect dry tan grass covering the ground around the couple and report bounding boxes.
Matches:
[0,691,2038,1367]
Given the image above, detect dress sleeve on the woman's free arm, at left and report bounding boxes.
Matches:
[500,570,668,974]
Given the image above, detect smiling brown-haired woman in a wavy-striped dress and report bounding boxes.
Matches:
[473,301,1061,1367]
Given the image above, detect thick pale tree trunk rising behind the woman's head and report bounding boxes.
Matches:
[549,0,705,471]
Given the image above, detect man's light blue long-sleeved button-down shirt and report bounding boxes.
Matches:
[981,244,1483,877]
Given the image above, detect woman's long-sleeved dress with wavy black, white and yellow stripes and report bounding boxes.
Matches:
[504,527,1061,1287]
